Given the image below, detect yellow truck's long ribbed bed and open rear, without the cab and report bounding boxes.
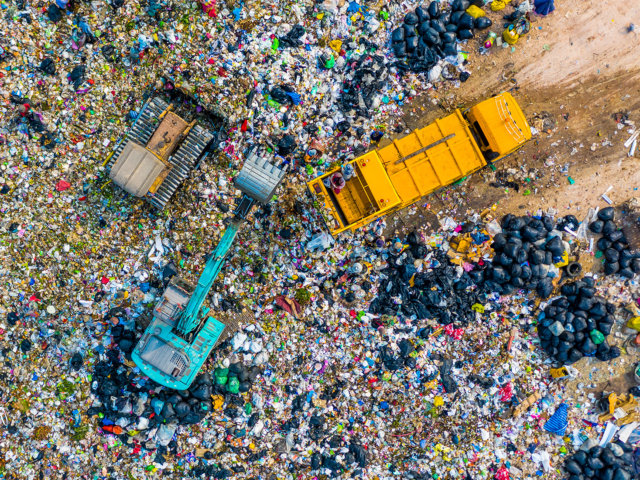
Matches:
[308,110,486,235]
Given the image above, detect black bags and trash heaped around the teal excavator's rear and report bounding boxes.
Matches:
[87,325,261,438]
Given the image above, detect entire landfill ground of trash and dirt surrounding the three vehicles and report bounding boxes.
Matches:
[0,0,640,480]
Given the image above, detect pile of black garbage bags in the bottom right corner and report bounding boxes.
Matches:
[564,442,637,480]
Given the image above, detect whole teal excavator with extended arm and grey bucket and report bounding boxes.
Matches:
[131,153,285,390]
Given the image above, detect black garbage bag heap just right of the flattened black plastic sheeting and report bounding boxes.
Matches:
[470,214,566,298]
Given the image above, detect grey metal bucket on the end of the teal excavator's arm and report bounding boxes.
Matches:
[235,152,286,205]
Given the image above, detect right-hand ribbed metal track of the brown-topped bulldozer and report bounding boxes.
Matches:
[147,125,213,210]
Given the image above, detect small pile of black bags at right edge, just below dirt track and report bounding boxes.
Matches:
[589,207,640,278]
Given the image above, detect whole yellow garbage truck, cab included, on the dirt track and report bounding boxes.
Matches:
[308,92,531,235]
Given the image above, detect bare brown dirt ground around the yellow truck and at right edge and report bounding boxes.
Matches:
[387,0,640,401]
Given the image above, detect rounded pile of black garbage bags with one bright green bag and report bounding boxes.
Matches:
[538,277,620,364]
